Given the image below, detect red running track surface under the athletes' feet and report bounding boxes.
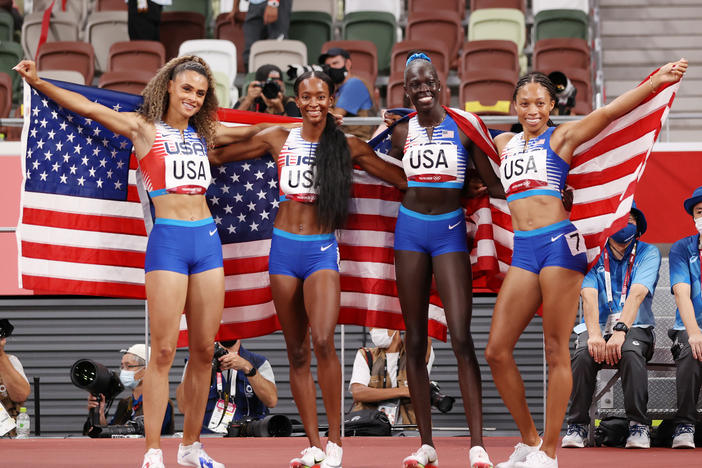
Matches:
[0,437,702,468]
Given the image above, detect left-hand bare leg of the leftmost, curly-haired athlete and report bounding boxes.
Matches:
[144,270,188,450]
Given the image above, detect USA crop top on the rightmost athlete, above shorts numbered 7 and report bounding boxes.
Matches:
[500,127,569,202]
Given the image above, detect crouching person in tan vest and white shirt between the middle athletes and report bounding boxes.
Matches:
[349,328,434,425]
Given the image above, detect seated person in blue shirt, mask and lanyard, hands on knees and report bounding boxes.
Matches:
[561,206,661,448]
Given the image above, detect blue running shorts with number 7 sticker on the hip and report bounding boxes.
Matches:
[512,219,587,274]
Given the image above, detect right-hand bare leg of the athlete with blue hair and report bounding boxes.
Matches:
[432,252,483,446]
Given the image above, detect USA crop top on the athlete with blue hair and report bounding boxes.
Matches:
[402,114,468,189]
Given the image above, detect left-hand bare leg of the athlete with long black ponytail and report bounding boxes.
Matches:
[271,275,324,450]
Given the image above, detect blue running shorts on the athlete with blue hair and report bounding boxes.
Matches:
[395,205,468,257]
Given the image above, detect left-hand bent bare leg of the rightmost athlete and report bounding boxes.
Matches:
[485,267,541,446]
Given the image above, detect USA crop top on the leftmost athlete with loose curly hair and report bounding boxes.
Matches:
[139,122,212,197]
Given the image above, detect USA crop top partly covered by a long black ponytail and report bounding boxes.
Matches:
[278,127,317,203]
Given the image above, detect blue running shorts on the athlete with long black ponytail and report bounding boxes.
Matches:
[268,228,339,280]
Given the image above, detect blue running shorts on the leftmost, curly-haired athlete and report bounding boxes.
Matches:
[144,217,222,275]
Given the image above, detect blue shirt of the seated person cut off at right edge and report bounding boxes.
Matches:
[668,234,702,330]
